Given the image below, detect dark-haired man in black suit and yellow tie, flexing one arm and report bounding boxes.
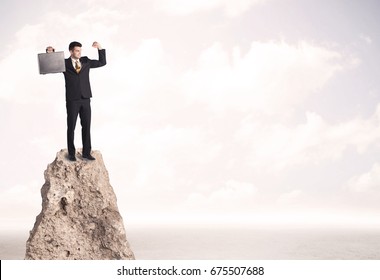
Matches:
[63,42,106,161]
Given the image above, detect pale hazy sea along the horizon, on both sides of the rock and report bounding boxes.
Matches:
[0,225,380,260]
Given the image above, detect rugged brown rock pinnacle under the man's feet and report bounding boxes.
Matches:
[25,150,134,260]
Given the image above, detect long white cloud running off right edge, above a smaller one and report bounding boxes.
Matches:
[239,104,380,170]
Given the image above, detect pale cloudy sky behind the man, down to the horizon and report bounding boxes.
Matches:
[0,0,380,228]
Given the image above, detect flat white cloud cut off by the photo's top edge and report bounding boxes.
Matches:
[155,0,264,17]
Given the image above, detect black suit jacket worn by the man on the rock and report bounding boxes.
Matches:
[63,49,107,101]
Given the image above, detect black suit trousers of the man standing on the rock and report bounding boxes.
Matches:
[66,98,91,155]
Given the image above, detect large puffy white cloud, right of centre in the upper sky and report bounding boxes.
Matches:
[181,42,345,114]
